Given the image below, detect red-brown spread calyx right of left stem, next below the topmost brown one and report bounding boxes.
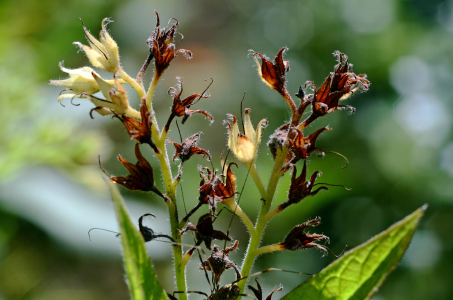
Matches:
[165,78,214,131]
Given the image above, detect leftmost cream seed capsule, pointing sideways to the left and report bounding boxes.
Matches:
[49,62,101,95]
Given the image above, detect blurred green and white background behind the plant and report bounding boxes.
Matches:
[0,0,453,300]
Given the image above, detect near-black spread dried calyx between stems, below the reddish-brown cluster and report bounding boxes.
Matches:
[181,213,231,250]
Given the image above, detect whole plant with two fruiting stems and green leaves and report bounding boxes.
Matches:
[50,13,424,300]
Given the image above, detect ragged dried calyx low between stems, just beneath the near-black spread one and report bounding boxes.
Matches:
[200,241,242,284]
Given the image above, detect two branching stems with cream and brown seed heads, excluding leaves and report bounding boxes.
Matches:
[50,13,370,299]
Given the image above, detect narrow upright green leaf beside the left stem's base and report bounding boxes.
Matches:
[107,179,168,300]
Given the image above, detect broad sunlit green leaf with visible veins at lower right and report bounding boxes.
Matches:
[282,205,427,300]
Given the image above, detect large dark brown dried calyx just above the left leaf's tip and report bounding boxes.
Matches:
[101,144,170,202]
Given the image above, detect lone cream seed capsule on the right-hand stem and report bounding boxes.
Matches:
[228,109,267,166]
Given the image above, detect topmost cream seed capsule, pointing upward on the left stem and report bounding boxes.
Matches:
[74,18,120,73]
